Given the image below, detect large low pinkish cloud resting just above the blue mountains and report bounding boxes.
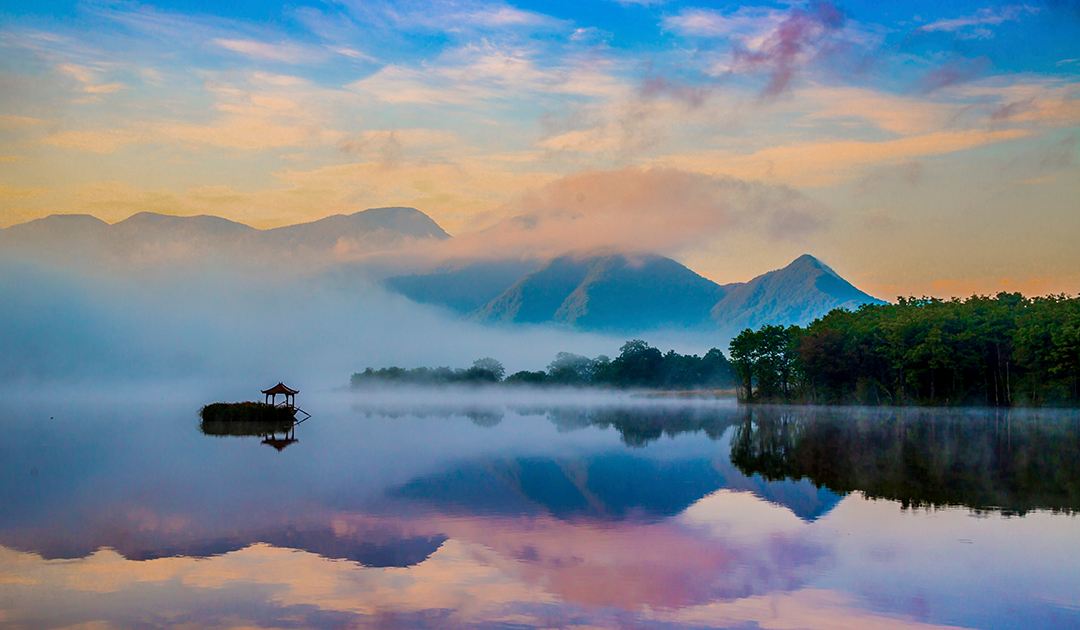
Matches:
[444,167,824,256]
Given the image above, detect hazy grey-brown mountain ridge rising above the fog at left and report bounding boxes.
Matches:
[0,207,450,265]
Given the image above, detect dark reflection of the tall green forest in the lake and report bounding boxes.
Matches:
[731,407,1080,514]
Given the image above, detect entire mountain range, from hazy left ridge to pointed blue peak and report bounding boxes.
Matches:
[0,206,881,334]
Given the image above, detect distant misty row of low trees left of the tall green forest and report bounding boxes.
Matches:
[350,339,734,389]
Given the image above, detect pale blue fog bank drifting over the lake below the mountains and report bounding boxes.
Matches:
[0,262,726,389]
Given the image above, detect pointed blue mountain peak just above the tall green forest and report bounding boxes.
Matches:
[710,254,885,332]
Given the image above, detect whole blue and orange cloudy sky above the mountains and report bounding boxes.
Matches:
[0,0,1080,298]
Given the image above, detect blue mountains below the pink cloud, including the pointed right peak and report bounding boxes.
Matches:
[386,254,881,334]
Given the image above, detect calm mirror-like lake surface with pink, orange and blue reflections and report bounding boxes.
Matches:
[0,390,1080,628]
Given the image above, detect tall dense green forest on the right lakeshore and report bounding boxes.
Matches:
[729,293,1080,406]
